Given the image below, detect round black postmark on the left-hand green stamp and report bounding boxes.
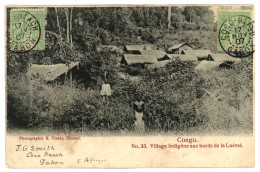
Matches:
[10,11,41,52]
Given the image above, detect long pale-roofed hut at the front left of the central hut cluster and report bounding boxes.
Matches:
[121,54,158,68]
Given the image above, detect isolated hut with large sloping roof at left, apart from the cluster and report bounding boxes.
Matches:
[27,62,79,85]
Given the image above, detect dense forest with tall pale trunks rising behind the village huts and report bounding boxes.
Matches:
[7,6,216,74]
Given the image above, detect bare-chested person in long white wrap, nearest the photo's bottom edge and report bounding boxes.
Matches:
[134,95,144,132]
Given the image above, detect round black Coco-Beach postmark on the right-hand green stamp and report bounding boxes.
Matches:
[219,15,253,58]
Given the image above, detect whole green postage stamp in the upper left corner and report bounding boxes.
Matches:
[10,8,45,52]
